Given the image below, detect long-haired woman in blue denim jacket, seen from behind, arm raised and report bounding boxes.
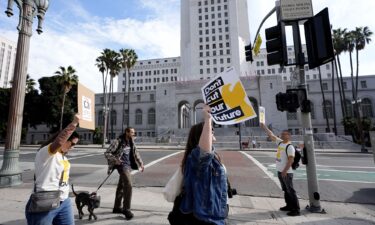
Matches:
[180,106,228,225]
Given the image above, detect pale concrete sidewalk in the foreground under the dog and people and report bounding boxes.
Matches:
[0,184,375,225]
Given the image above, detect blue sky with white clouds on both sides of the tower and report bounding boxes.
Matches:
[0,0,375,93]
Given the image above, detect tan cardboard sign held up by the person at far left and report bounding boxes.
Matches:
[77,83,95,130]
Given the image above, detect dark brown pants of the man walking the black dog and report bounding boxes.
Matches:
[113,170,133,210]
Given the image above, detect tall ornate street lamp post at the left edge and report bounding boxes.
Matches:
[0,0,49,187]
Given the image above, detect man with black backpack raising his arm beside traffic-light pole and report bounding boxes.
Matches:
[261,123,300,216]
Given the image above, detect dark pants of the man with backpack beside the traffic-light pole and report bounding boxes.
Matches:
[277,172,300,211]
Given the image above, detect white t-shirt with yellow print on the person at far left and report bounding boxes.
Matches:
[35,145,70,201]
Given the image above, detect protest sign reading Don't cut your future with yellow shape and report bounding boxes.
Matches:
[202,67,257,125]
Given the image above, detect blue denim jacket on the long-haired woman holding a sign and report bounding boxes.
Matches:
[180,147,228,225]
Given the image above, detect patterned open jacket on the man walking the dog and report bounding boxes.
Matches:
[104,138,143,174]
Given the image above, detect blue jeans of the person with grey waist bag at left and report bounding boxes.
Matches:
[25,198,74,225]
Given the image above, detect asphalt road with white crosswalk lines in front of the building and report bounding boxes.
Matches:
[0,147,375,204]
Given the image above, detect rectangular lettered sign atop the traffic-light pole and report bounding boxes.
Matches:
[280,0,313,21]
